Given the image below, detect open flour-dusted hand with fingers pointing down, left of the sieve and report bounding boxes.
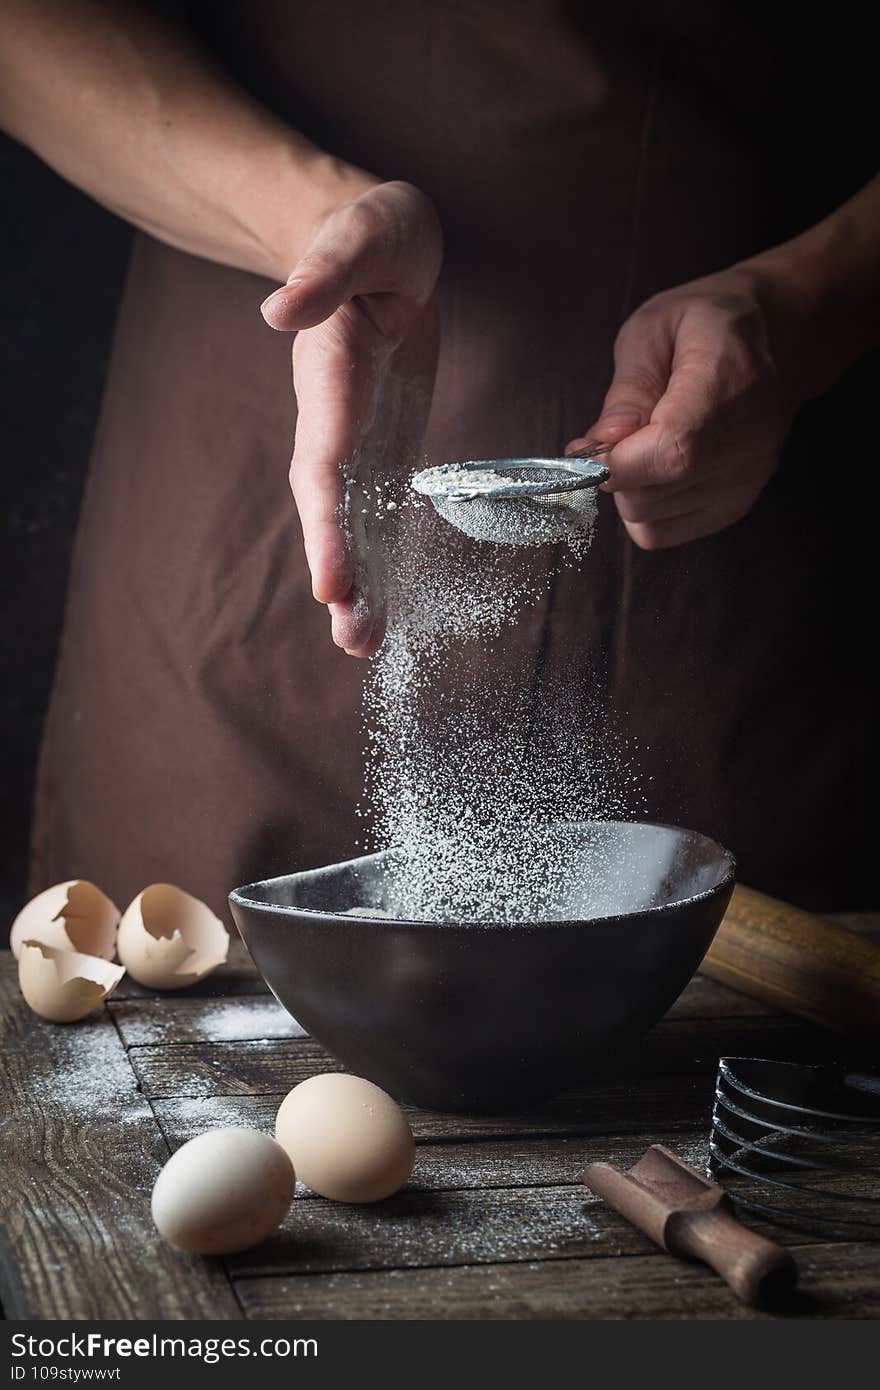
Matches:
[261,183,442,656]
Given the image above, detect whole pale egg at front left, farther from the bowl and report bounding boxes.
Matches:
[153,1129,296,1255]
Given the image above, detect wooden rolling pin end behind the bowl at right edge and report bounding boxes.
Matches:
[699,884,880,1034]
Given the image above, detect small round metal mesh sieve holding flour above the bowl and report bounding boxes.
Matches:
[412,443,612,545]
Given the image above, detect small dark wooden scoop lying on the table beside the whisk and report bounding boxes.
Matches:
[581,1144,798,1305]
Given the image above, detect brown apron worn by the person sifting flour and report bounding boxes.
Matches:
[33,0,876,910]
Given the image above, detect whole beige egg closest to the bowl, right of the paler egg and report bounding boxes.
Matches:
[275,1073,416,1202]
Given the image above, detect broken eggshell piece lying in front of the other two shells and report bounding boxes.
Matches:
[18,941,125,1023]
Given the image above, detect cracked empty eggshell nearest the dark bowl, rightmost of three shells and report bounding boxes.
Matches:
[117,883,229,990]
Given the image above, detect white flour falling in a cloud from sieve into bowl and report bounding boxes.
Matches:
[361,478,631,922]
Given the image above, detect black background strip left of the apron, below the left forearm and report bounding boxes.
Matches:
[0,138,131,945]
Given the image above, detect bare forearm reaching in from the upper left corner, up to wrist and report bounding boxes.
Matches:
[0,0,375,281]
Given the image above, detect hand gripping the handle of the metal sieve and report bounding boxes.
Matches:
[569,263,802,550]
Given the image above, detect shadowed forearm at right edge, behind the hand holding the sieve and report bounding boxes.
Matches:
[745,178,880,396]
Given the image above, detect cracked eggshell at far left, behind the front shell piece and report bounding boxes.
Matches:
[10,878,120,960]
